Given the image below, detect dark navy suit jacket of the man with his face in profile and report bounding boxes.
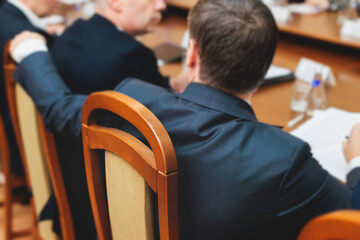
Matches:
[51,15,168,94]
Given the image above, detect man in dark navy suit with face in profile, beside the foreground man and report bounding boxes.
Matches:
[51,0,188,94]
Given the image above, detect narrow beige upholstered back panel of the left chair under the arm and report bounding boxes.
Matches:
[15,84,57,240]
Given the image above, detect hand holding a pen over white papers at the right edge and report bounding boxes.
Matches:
[343,123,360,163]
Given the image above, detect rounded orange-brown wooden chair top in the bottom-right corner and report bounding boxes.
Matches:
[297,210,360,240]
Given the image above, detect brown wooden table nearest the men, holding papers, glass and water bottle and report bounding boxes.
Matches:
[139,11,360,130]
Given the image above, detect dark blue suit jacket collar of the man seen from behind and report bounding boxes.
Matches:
[179,83,257,121]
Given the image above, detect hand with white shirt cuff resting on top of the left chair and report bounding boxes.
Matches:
[10,31,47,63]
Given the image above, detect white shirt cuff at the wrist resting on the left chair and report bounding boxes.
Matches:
[12,38,48,63]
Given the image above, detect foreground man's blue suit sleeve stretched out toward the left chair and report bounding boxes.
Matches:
[14,52,86,138]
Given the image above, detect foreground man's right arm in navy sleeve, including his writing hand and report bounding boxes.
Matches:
[275,123,360,239]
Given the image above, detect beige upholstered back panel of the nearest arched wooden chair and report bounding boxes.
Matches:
[105,151,154,240]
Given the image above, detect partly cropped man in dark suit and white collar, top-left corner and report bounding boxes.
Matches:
[0,0,58,175]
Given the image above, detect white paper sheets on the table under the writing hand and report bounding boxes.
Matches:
[291,108,360,181]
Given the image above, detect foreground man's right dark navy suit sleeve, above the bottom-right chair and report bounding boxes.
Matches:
[275,143,353,239]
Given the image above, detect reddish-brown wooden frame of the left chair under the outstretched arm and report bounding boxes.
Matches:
[4,42,75,240]
